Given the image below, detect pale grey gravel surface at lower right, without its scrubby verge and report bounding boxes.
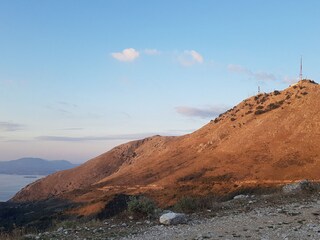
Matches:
[121,202,320,240]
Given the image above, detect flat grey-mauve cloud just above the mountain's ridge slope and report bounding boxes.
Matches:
[175,106,228,118]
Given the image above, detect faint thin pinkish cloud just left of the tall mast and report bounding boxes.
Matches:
[227,64,277,81]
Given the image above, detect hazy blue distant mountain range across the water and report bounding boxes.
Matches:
[0,158,78,175]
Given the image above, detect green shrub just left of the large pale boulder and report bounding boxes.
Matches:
[128,196,156,216]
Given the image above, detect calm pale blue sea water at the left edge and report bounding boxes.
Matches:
[0,174,44,202]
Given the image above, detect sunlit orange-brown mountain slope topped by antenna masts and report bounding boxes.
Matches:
[11,80,320,218]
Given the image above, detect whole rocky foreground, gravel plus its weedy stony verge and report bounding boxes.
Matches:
[18,188,320,240]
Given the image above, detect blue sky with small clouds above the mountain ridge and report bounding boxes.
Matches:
[0,0,320,163]
